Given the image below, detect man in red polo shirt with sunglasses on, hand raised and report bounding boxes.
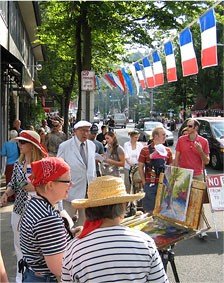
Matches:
[174,119,210,238]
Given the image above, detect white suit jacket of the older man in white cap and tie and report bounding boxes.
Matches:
[57,137,96,201]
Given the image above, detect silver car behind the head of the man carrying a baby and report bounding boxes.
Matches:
[135,121,174,145]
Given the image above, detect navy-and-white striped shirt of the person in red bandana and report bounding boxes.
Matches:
[20,197,70,277]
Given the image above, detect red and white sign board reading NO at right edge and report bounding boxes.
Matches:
[206,174,224,211]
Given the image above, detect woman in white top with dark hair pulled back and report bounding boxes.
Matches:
[124,130,143,194]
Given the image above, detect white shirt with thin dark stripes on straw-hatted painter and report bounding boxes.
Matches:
[61,226,168,283]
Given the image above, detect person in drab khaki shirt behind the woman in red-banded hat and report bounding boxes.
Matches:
[45,117,67,156]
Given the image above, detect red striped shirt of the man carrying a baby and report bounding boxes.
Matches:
[138,143,173,183]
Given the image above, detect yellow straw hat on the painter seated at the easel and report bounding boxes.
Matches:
[72,176,145,208]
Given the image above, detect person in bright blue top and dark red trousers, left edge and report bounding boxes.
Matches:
[1,130,19,201]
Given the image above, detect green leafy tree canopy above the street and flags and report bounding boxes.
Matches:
[36,1,221,132]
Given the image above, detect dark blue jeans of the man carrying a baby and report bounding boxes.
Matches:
[142,182,158,211]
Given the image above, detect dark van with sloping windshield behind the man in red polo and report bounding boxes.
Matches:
[178,117,224,169]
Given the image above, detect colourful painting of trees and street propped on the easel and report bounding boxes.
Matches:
[154,166,193,222]
